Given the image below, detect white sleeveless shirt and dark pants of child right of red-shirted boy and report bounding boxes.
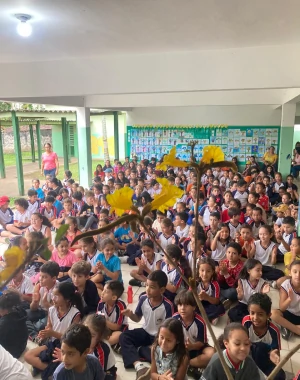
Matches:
[228,278,266,323]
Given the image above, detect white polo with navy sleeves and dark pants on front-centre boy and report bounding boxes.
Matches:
[119,295,173,368]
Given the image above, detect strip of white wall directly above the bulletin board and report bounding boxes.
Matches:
[127,106,281,126]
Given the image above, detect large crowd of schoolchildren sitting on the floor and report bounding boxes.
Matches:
[0,158,300,380]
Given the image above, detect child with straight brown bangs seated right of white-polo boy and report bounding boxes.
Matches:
[173,290,215,372]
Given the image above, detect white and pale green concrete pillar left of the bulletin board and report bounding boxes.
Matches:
[76,107,92,188]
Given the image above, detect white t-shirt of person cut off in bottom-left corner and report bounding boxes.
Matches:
[0,345,32,380]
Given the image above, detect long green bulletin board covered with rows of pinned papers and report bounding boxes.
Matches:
[126,125,280,164]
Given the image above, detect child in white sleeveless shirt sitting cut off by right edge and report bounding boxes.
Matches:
[272,260,300,340]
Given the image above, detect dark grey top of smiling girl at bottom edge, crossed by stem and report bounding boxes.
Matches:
[200,350,262,380]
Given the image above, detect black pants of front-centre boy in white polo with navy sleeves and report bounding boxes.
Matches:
[119,328,155,368]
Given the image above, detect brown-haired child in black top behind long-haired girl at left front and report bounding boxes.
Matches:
[69,260,100,315]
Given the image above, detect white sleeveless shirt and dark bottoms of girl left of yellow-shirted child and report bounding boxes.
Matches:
[254,240,284,281]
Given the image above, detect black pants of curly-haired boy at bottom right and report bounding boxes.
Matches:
[251,342,285,380]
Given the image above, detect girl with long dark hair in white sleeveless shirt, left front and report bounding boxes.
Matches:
[24,281,83,378]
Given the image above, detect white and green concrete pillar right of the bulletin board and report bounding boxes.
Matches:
[278,103,296,180]
